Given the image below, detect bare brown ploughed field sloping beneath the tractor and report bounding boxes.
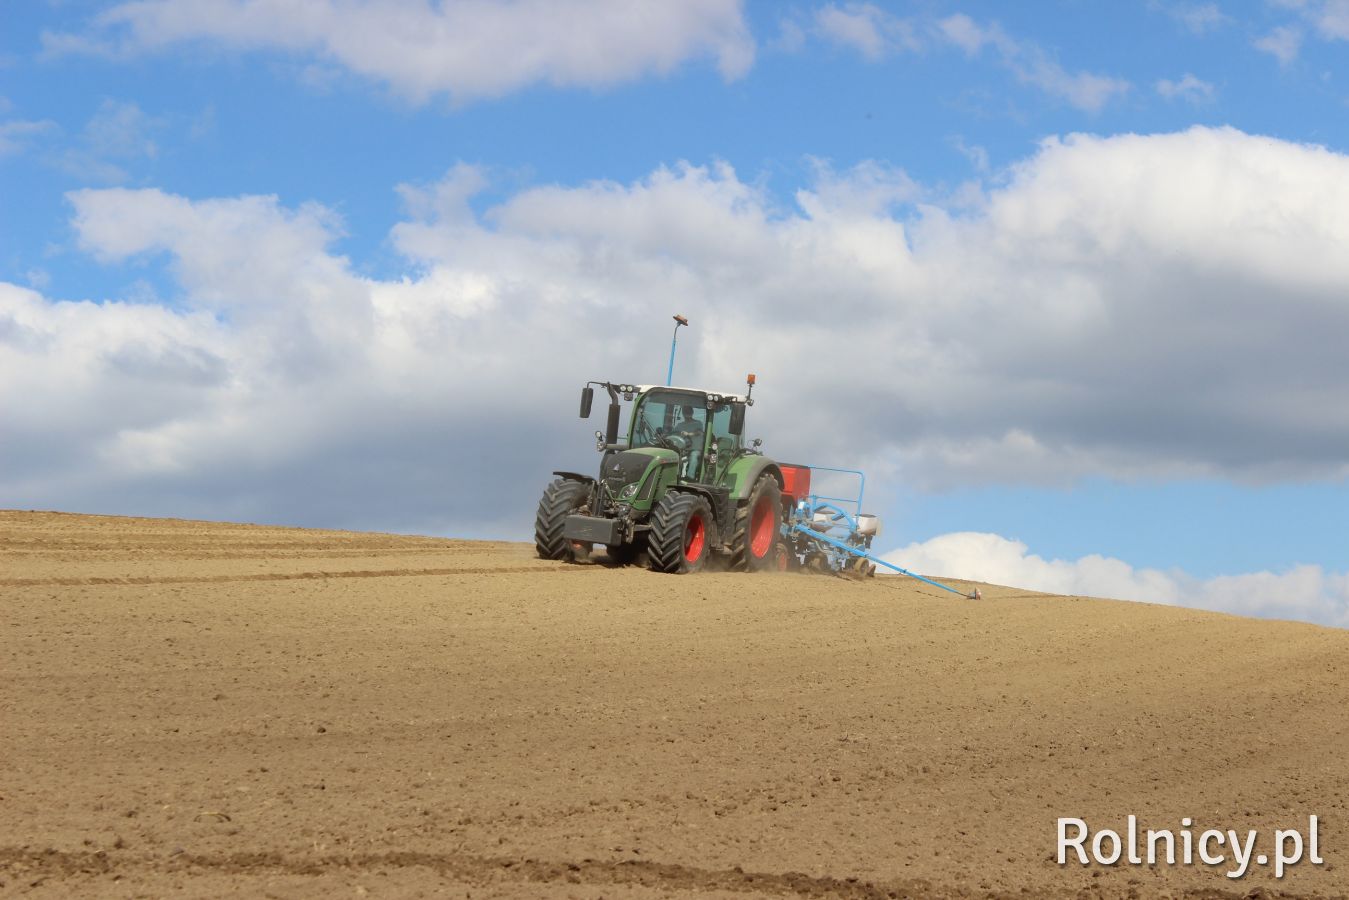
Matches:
[0,511,1349,897]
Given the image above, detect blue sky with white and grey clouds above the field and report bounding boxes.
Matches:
[0,0,1349,627]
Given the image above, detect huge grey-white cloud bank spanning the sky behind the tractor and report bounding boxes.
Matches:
[0,128,1349,612]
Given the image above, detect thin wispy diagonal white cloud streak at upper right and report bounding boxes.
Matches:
[936,13,1129,112]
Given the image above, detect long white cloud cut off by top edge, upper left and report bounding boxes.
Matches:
[43,0,754,101]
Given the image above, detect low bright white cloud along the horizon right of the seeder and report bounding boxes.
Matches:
[882,532,1349,627]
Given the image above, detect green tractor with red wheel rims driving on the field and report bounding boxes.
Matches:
[534,375,791,573]
